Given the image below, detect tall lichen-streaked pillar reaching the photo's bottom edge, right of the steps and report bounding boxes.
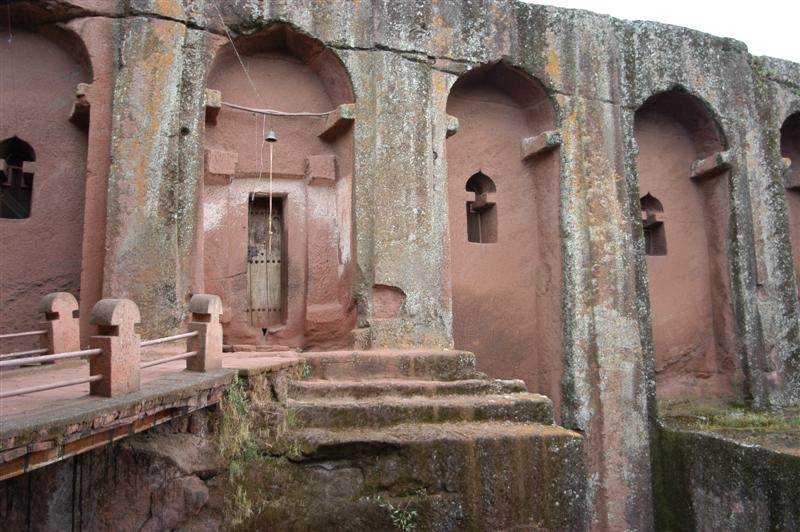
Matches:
[558,96,653,530]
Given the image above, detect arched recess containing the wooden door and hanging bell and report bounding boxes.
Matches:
[203,24,356,349]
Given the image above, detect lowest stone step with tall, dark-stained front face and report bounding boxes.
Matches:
[253,422,586,531]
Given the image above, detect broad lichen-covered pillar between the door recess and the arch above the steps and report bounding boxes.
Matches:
[343,51,452,348]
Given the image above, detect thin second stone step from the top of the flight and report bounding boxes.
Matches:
[289,379,528,399]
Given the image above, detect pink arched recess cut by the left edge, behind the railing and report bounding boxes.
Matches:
[0,28,91,344]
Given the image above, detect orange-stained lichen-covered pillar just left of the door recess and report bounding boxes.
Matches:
[103,15,194,336]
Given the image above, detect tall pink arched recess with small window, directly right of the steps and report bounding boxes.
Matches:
[446,62,562,411]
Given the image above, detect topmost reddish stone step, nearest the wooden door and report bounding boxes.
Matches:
[301,350,478,381]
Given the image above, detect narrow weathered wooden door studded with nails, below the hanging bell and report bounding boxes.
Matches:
[247,196,287,329]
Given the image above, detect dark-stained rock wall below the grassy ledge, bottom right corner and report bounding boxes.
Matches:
[655,426,800,531]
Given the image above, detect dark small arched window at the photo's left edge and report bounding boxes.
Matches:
[0,137,36,219]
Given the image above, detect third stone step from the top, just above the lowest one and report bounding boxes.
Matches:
[286,393,553,428]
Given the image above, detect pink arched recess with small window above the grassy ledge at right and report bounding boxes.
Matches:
[634,88,740,399]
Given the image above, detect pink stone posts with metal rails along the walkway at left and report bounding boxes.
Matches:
[0,294,222,398]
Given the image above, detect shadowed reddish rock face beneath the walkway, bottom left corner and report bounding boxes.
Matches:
[0,412,225,532]
